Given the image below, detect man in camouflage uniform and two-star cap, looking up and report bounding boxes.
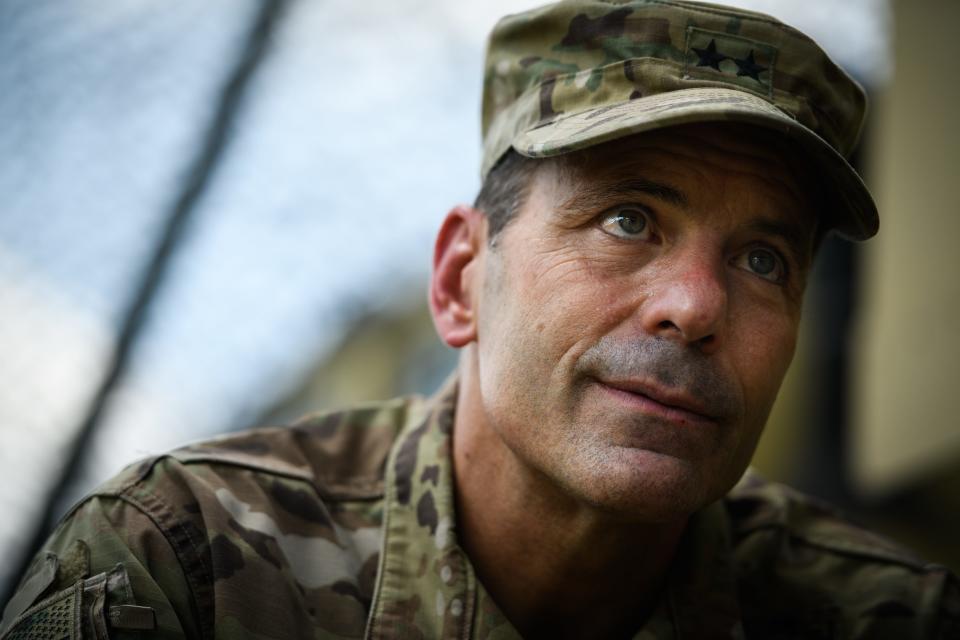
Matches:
[2,0,960,638]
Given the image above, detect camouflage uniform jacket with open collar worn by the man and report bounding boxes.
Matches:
[2,378,960,640]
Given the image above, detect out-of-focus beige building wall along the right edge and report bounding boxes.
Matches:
[852,0,960,496]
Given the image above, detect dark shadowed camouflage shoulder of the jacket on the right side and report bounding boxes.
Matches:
[724,472,960,638]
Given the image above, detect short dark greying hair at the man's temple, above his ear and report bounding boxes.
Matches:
[473,148,537,246]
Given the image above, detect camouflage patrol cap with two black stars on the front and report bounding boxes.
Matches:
[482,0,879,240]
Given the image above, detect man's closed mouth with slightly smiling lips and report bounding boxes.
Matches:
[593,378,720,425]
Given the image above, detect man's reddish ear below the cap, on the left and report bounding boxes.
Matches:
[430,206,487,348]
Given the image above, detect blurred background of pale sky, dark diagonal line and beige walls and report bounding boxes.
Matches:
[0,0,960,604]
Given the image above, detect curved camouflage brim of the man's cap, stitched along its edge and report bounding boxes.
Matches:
[513,88,880,240]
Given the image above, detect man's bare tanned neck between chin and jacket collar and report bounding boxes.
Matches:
[453,360,686,638]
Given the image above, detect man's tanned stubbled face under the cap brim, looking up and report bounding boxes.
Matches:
[475,126,814,520]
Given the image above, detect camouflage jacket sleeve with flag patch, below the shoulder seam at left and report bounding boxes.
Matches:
[0,496,200,640]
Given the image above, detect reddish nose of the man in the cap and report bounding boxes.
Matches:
[640,250,727,352]
